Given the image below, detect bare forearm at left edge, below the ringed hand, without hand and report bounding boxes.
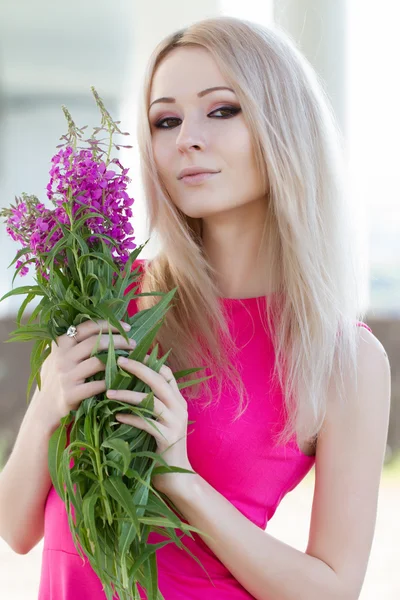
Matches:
[0,388,56,554]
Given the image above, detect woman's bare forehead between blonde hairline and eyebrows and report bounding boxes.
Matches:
[150,46,228,103]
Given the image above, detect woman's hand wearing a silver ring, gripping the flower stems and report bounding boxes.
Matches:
[32,320,136,429]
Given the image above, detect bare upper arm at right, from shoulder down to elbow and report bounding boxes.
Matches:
[306,327,391,598]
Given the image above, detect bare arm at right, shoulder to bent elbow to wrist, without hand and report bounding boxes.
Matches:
[168,327,390,600]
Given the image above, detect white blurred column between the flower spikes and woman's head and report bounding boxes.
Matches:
[120,0,220,258]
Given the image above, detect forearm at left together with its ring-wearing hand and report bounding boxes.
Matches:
[0,319,132,554]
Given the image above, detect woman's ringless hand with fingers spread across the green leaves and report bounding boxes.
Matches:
[107,355,193,495]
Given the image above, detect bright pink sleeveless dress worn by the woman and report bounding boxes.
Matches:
[39,260,371,600]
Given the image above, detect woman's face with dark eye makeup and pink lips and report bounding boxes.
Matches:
[149,47,264,219]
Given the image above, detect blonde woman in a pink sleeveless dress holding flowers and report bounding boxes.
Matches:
[0,17,390,600]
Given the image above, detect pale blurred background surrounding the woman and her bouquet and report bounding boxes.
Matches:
[0,0,400,600]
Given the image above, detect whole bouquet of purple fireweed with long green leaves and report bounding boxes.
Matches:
[0,87,211,600]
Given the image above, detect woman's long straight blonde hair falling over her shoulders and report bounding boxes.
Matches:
[137,16,363,450]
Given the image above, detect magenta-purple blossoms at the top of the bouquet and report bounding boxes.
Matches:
[0,146,136,279]
